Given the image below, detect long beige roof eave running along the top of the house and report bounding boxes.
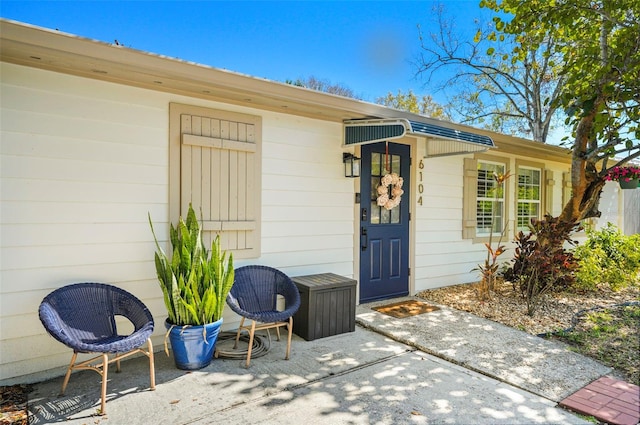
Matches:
[0,18,568,160]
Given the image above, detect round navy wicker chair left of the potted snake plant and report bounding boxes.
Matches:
[39,283,155,414]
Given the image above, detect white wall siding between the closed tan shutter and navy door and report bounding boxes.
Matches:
[255,114,354,276]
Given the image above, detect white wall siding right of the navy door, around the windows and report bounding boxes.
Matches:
[413,140,568,292]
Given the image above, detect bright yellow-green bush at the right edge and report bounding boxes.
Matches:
[575,223,640,291]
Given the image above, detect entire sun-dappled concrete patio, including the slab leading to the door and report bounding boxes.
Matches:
[29,300,609,425]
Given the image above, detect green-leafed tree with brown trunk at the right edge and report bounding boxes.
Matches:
[480,0,640,222]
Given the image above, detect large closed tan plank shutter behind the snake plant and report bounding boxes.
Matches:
[180,114,260,258]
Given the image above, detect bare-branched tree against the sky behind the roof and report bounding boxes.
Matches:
[417,5,564,142]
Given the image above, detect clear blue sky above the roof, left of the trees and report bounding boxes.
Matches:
[0,0,487,102]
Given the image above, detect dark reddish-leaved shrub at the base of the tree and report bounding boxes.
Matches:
[503,215,578,316]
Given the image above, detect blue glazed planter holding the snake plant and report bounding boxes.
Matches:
[164,319,222,370]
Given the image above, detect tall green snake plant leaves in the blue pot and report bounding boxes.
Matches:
[149,205,234,326]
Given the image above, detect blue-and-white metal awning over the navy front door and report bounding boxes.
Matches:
[344,118,495,157]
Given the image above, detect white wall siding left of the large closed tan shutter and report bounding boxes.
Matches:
[0,64,167,380]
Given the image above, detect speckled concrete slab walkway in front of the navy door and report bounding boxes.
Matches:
[356,297,612,402]
